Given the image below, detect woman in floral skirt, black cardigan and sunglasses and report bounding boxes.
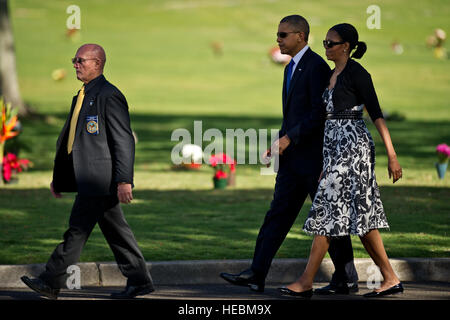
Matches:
[280,23,403,298]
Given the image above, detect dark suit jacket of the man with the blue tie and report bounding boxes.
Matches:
[279,48,331,174]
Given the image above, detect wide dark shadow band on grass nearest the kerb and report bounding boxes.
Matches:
[0,186,450,264]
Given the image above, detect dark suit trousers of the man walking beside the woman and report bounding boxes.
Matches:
[251,167,358,284]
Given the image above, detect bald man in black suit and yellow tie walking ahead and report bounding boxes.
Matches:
[22,44,154,299]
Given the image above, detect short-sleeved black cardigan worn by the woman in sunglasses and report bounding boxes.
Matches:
[333,59,383,121]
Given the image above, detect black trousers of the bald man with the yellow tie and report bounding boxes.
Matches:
[39,195,152,288]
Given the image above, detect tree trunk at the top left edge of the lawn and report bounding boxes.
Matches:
[0,0,28,116]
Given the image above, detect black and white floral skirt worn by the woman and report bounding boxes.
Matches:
[303,90,389,237]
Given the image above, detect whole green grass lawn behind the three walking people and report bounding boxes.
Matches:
[0,0,450,264]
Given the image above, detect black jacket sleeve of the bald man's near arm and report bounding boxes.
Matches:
[105,92,135,184]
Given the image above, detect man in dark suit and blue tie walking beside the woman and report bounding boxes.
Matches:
[220,15,358,294]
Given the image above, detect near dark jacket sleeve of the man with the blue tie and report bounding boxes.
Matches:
[287,62,330,144]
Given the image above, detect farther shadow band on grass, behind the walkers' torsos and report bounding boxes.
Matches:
[14,113,450,170]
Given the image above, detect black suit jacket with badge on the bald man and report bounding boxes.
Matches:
[53,75,135,196]
